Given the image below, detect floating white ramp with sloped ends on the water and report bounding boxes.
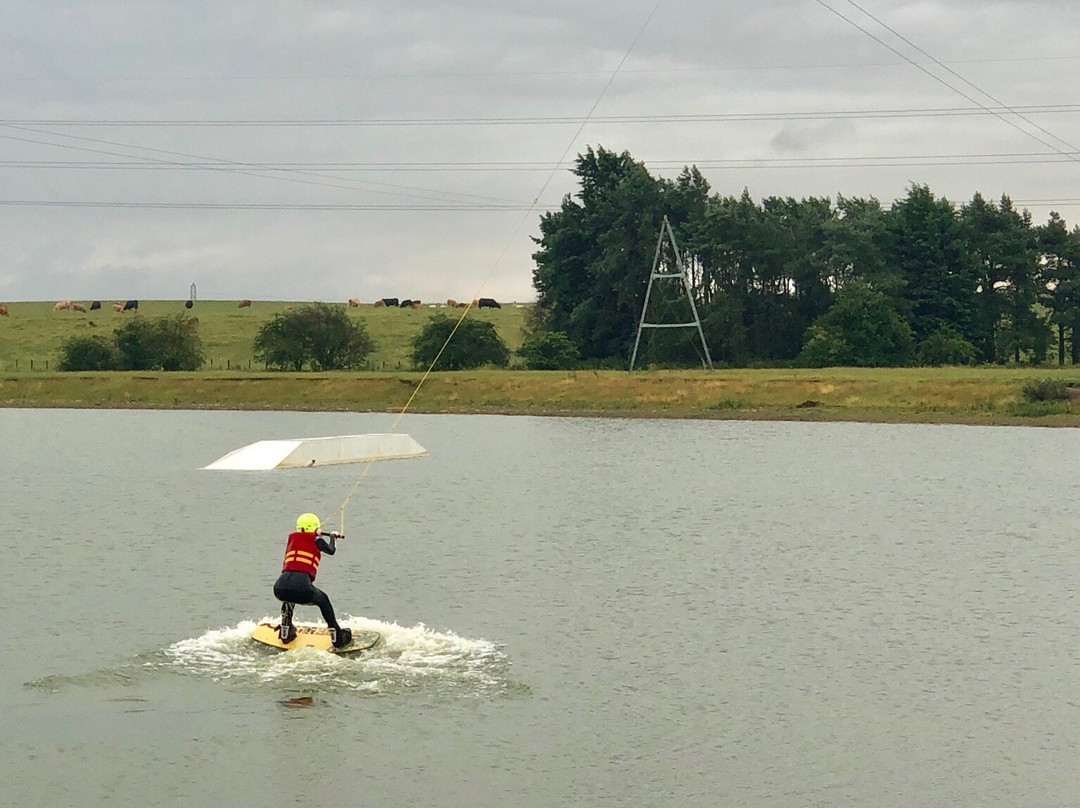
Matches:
[203,433,428,471]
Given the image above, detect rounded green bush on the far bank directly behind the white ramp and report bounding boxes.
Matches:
[253,302,375,371]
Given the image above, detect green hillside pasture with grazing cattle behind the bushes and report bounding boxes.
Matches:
[0,300,525,373]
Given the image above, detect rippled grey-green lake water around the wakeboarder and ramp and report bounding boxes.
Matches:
[0,409,1080,808]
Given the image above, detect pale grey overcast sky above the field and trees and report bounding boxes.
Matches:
[0,0,1080,301]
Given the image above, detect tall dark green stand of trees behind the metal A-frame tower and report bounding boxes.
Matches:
[532,148,1080,366]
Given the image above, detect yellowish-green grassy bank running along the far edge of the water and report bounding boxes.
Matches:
[0,368,1080,426]
